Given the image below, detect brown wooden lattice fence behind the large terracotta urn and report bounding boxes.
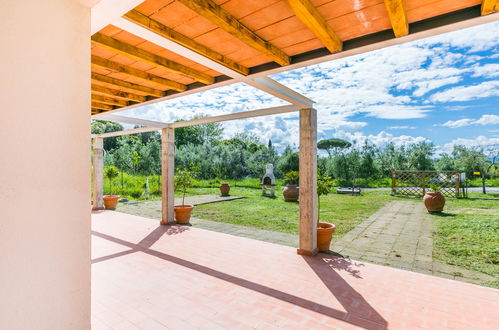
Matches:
[392,171,462,198]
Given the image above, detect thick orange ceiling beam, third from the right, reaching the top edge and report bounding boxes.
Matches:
[287,0,343,53]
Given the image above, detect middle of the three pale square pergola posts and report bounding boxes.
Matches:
[161,128,175,225]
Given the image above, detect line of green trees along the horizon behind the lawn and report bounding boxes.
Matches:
[92,121,496,185]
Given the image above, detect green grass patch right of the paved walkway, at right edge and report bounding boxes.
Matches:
[433,199,499,288]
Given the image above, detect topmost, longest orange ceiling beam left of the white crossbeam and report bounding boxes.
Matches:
[92,33,215,85]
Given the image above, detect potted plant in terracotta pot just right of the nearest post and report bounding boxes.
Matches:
[317,171,336,252]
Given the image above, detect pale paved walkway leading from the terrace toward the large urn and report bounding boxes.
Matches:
[331,201,494,283]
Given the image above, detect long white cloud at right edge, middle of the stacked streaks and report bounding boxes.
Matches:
[430,81,499,102]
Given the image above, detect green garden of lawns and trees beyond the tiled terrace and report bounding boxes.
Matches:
[92,122,499,287]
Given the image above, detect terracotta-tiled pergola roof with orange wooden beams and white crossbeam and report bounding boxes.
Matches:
[91,0,499,118]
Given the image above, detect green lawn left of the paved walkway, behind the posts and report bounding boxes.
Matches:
[188,187,393,238]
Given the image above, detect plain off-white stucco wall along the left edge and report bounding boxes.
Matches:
[0,0,90,330]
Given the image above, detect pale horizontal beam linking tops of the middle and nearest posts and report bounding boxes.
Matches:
[169,105,300,128]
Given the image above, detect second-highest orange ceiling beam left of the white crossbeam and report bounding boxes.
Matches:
[92,55,187,92]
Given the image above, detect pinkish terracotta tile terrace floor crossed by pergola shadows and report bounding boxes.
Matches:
[92,211,499,329]
